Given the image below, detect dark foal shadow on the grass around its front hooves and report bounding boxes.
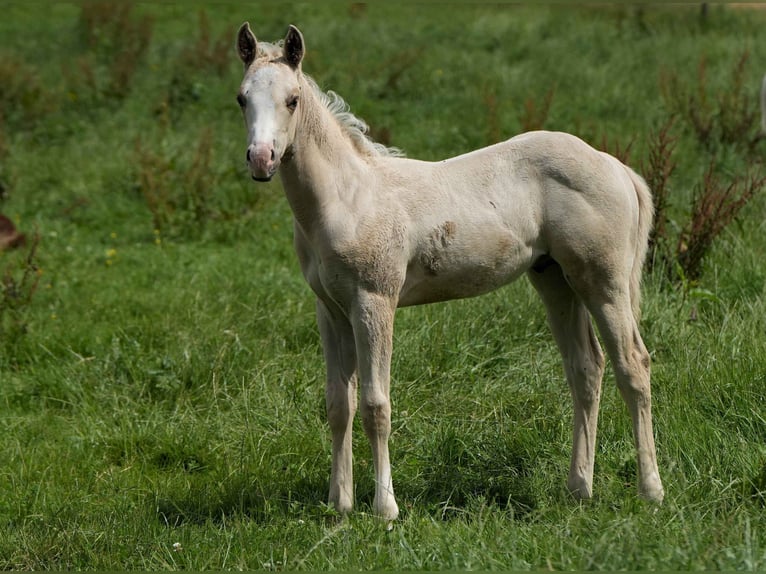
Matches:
[154,448,539,527]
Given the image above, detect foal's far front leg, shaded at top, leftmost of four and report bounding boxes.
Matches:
[317,299,356,514]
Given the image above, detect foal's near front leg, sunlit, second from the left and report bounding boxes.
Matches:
[351,292,399,520]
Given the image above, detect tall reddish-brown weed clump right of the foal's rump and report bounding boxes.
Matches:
[646,51,766,285]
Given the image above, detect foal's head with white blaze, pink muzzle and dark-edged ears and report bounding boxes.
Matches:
[237,22,304,181]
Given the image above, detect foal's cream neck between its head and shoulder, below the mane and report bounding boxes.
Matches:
[280,79,369,236]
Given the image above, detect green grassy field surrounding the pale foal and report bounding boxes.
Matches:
[0,2,766,570]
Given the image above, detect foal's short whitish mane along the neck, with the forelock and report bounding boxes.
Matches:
[258,40,404,157]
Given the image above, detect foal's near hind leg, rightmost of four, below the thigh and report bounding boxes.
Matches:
[588,280,664,502]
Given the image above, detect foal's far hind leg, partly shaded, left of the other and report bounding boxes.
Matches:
[528,263,604,498]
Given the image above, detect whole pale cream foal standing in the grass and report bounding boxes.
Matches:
[237,23,663,519]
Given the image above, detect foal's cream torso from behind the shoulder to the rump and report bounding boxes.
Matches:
[392,131,638,305]
